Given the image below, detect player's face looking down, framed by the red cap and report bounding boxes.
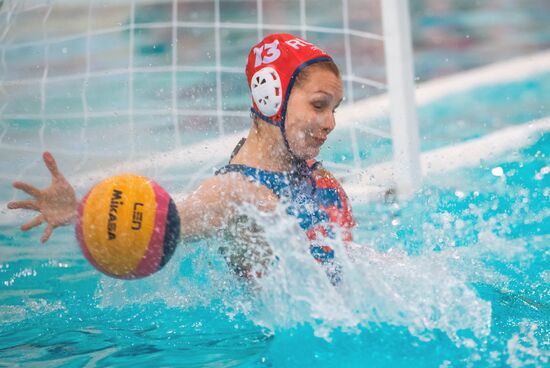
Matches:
[285,64,342,160]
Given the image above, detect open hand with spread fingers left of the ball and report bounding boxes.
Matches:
[8,152,78,243]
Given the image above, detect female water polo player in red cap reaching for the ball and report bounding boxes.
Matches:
[8,34,354,280]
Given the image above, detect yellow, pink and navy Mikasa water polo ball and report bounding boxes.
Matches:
[76,174,180,279]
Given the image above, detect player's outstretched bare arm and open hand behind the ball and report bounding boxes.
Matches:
[8,152,277,266]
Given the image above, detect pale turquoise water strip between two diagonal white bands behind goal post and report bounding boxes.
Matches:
[320,73,550,165]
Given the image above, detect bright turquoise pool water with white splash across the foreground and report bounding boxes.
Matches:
[0,91,550,367]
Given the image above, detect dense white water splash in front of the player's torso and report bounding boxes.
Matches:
[244,203,491,344]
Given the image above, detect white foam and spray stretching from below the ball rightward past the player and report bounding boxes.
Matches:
[96,206,500,346]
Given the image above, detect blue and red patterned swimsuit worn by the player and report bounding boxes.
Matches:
[216,160,355,283]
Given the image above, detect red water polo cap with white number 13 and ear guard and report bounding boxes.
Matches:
[246,33,332,129]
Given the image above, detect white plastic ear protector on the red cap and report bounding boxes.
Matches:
[250,67,283,117]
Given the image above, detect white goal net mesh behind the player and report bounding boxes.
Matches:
[0,0,390,207]
